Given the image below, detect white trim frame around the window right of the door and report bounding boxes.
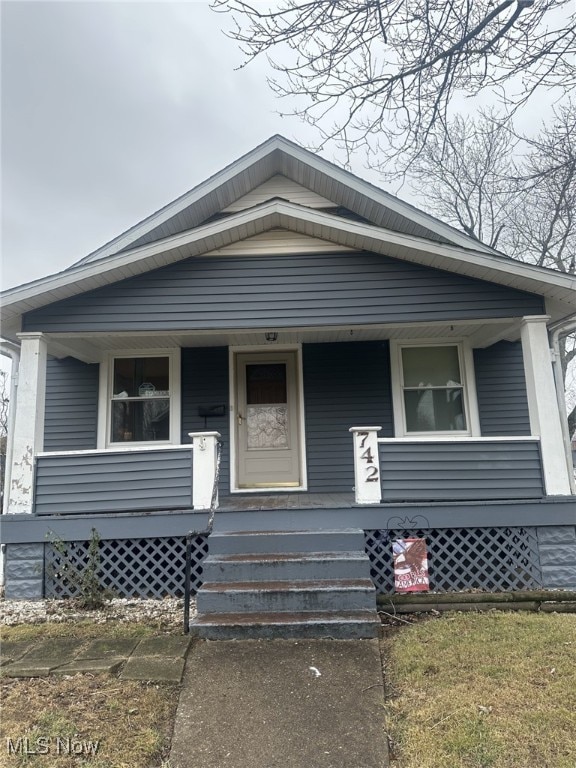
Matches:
[390,338,481,440]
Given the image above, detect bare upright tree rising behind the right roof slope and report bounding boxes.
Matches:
[411,106,576,434]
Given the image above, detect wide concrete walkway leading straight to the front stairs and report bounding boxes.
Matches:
[170,640,388,768]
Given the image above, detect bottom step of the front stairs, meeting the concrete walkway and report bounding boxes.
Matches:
[190,610,380,640]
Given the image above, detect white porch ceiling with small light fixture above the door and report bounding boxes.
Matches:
[46,318,520,363]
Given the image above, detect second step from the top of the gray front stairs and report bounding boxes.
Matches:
[202,552,370,582]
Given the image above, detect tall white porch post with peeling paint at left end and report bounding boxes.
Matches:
[7,333,47,514]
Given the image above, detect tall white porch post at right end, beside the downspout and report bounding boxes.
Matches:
[521,315,571,496]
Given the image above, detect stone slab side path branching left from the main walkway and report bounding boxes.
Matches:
[0,635,191,683]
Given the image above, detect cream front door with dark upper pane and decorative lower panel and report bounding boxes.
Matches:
[236,351,302,488]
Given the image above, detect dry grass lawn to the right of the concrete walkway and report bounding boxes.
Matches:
[384,611,576,768]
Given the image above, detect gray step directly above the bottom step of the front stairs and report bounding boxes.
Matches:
[196,579,376,613]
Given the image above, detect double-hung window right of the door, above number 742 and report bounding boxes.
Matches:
[393,344,473,435]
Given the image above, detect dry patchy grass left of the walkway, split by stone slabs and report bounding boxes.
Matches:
[0,623,179,768]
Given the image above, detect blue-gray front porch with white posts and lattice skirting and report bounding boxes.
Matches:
[2,319,576,597]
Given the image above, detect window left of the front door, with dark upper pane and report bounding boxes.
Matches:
[102,353,179,445]
